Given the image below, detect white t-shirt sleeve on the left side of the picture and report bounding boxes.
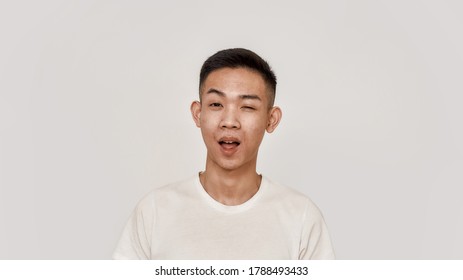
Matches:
[112,195,155,260]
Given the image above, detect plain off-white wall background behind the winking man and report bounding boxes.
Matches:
[0,0,463,259]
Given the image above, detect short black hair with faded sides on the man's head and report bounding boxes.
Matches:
[199,48,277,106]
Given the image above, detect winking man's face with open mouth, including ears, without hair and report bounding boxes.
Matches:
[191,68,281,171]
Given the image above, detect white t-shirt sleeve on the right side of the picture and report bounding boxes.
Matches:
[299,202,335,260]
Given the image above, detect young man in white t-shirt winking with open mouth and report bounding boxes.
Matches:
[113,49,334,259]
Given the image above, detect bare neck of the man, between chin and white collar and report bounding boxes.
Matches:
[199,158,262,206]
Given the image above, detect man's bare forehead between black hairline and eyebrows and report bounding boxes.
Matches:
[201,68,268,98]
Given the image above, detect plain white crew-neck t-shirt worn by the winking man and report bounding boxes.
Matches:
[113,175,334,260]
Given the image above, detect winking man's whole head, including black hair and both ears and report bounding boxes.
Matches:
[190,49,282,171]
